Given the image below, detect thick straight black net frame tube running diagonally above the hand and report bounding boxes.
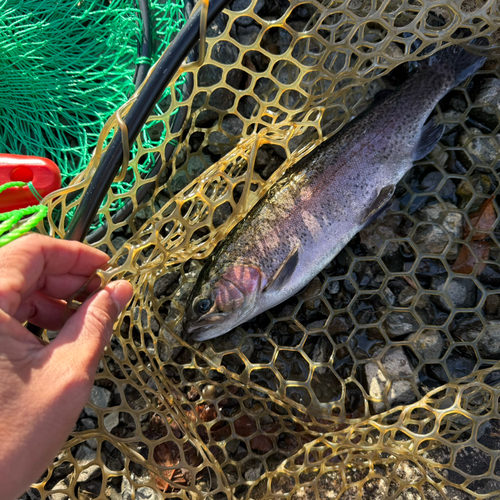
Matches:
[65,0,230,241]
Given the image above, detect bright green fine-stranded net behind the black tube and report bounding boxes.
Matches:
[0,0,185,225]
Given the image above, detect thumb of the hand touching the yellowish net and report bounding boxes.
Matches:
[47,281,133,380]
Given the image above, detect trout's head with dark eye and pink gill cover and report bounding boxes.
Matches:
[183,264,267,341]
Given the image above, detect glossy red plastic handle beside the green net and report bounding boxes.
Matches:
[0,154,61,213]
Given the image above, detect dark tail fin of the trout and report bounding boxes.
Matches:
[428,38,487,85]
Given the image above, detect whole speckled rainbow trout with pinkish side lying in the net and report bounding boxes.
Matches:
[184,46,485,340]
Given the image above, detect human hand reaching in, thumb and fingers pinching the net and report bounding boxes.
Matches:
[0,234,132,500]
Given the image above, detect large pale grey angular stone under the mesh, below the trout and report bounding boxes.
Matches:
[365,347,417,413]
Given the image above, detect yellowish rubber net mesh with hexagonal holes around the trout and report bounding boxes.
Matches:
[29,0,500,500]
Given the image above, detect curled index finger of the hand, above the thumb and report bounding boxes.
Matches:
[0,233,109,314]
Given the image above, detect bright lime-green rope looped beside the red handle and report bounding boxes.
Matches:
[0,182,48,247]
